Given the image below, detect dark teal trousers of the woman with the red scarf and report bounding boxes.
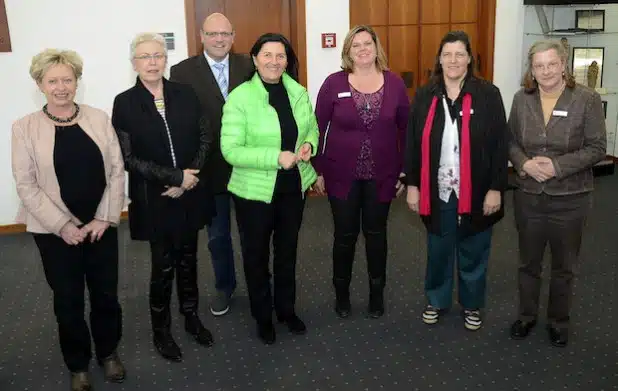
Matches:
[425,195,492,309]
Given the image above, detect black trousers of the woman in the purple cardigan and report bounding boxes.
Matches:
[329,180,391,287]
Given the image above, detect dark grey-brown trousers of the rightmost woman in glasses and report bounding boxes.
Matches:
[514,190,592,329]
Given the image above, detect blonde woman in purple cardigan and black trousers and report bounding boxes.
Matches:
[314,26,409,318]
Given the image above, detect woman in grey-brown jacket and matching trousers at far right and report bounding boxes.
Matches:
[509,41,607,347]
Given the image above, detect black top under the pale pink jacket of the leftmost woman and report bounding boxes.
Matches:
[54,124,107,224]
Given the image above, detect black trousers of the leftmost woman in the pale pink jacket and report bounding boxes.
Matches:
[34,227,122,372]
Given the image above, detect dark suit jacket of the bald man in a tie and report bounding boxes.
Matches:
[170,53,254,194]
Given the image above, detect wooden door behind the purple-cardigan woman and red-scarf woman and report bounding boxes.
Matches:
[350,0,496,96]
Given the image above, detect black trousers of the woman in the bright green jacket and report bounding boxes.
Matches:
[234,192,305,324]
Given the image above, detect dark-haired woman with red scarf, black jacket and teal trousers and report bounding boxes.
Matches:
[406,31,508,331]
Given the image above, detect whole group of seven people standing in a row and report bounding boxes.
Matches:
[12,9,606,391]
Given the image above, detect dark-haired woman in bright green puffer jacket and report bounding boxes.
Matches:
[221,33,318,344]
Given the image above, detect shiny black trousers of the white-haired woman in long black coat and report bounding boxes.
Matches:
[150,231,198,332]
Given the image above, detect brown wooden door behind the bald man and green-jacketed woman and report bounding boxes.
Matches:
[185,0,307,86]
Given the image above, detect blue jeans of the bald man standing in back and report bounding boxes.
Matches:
[207,193,236,296]
